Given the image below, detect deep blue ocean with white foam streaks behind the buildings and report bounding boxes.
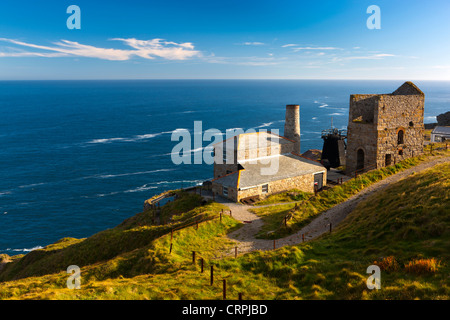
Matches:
[0,80,450,255]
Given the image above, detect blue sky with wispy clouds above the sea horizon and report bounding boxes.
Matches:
[0,0,450,80]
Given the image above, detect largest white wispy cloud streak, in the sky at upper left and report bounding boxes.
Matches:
[0,38,201,61]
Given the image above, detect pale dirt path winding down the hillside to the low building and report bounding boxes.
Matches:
[211,157,450,253]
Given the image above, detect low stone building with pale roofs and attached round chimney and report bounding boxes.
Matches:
[212,105,327,202]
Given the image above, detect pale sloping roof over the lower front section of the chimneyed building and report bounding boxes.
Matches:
[213,154,326,189]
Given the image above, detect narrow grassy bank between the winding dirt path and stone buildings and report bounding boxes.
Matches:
[251,145,449,239]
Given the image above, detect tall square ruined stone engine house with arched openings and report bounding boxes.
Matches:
[346,82,425,175]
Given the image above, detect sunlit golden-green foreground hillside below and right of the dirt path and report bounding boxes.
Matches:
[0,164,450,299]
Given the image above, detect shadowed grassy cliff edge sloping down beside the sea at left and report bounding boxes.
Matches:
[0,193,232,281]
